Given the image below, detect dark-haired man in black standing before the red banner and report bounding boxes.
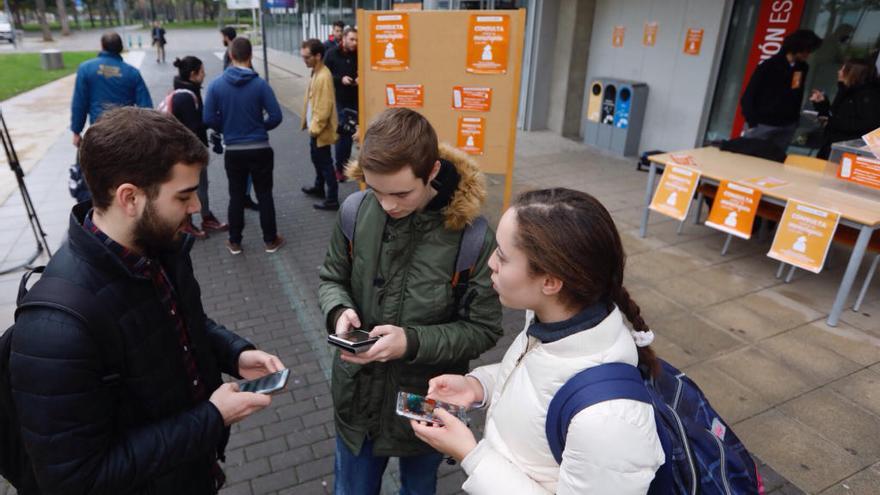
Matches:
[740,29,822,151]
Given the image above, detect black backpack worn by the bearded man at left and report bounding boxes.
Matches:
[0,266,122,490]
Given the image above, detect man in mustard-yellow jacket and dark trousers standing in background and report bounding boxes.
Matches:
[300,39,339,210]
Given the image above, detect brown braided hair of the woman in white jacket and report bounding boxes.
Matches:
[513,188,660,376]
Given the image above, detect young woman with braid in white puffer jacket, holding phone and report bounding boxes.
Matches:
[412,189,664,495]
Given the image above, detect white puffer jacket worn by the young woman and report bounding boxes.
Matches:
[462,308,664,495]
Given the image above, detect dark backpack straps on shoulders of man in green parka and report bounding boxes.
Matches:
[339,189,489,318]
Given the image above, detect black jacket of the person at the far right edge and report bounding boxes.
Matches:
[813,83,880,158]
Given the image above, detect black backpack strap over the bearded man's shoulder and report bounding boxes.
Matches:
[15,266,123,383]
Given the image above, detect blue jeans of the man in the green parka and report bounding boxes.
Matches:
[333,436,443,495]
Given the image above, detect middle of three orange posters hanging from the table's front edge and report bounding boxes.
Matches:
[706,180,761,239]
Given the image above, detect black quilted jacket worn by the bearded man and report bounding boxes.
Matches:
[10,203,253,495]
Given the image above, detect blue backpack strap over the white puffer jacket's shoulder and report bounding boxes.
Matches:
[544,363,653,464]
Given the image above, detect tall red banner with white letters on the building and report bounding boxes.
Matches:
[730,0,806,138]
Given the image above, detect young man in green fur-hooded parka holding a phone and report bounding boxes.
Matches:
[318,109,502,495]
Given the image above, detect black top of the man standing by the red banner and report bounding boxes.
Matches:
[740,53,810,127]
